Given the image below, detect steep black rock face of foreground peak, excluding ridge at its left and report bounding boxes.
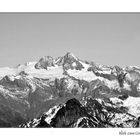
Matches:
[50,99,86,128]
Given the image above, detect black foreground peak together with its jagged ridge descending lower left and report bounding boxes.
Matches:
[20,98,87,128]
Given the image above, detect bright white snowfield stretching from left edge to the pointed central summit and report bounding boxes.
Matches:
[0,62,64,80]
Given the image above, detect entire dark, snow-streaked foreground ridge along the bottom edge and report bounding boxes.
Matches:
[20,97,140,128]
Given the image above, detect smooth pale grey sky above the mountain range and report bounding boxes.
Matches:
[0,13,140,67]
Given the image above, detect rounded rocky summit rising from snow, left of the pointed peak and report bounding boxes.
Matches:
[35,56,54,70]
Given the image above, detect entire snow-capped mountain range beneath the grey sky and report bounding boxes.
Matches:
[0,53,140,127]
